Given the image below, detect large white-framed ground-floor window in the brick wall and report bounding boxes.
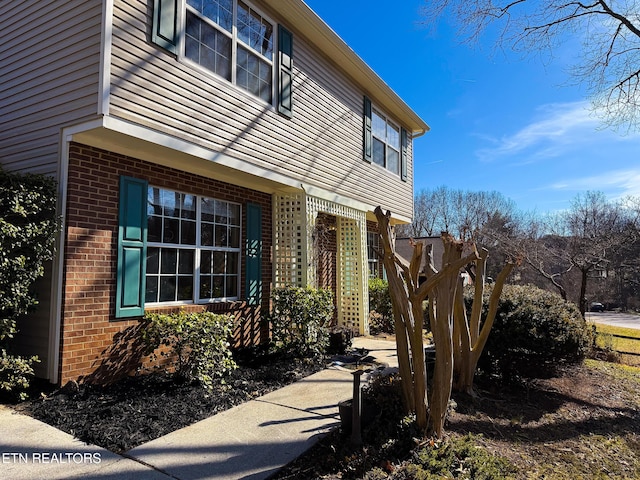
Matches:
[145,186,242,304]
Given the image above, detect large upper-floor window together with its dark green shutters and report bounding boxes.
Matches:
[151,0,294,118]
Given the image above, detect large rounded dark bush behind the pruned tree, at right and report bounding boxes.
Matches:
[466,285,593,381]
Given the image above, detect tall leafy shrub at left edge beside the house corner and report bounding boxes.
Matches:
[0,168,58,399]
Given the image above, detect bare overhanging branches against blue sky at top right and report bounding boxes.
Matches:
[422,0,640,130]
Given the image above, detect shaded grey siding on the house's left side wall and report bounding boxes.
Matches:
[0,1,102,175]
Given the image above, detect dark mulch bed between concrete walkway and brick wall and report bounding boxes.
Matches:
[17,356,326,453]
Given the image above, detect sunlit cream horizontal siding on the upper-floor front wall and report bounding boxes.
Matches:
[111,0,413,217]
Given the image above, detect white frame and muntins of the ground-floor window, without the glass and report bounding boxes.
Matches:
[144,184,243,308]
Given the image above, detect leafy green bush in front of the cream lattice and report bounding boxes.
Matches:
[269,287,334,356]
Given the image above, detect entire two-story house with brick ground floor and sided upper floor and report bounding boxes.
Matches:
[0,0,428,383]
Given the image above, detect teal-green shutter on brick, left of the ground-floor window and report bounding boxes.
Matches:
[116,177,148,318]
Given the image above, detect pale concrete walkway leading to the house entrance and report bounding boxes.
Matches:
[0,337,397,480]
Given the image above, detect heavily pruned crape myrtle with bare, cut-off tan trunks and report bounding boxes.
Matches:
[375,207,513,438]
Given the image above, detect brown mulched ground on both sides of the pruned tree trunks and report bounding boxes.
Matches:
[269,366,640,480]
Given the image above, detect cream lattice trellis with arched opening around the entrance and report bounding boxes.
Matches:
[273,192,369,335]
